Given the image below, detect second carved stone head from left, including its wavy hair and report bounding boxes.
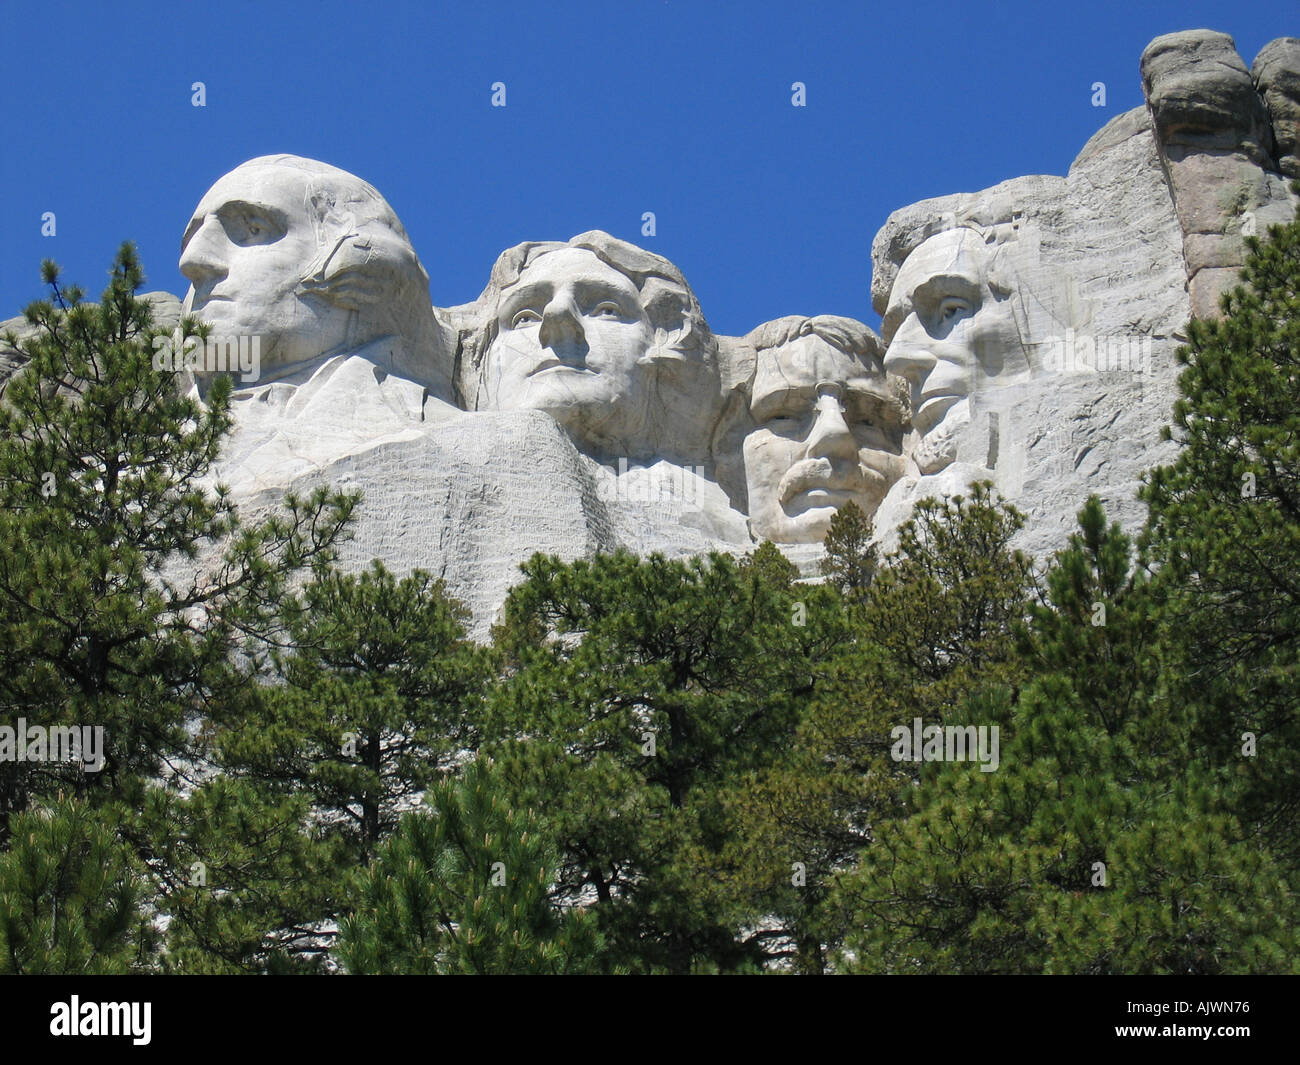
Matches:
[462,230,720,458]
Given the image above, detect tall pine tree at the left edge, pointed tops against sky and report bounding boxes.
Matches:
[0,243,355,827]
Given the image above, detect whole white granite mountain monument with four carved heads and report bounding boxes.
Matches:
[5,30,1300,633]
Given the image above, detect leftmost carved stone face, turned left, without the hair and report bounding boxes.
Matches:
[181,161,351,371]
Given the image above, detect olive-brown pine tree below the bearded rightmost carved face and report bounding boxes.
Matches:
[719,485,1032,973]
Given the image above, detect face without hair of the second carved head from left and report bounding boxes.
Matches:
[484,248,654,447]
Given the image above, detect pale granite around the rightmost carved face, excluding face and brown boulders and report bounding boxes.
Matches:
[872,109,1187,557]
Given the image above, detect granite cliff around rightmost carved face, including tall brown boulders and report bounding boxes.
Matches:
[871,30,1300,557]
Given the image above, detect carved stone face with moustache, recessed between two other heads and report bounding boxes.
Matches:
[742,334,904,544]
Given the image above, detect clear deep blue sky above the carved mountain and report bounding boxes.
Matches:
[0,0,1300,333]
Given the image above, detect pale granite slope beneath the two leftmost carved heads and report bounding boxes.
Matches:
[213,401,753,637]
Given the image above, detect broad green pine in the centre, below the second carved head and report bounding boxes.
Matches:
[485,549,837,973]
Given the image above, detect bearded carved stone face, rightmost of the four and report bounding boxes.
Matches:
[883,229,1028,437]
